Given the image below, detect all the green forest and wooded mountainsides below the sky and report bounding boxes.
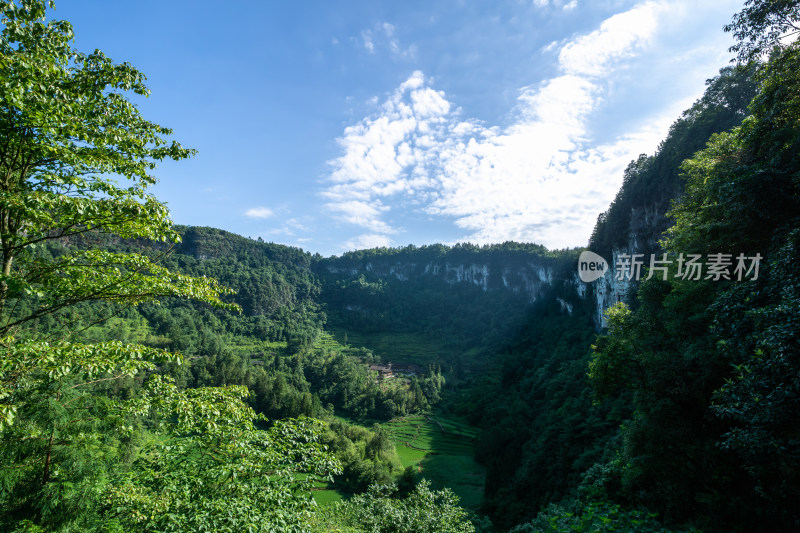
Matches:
[0,0,800,533]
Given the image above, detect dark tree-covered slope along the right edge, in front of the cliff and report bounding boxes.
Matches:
[590,37,800,531]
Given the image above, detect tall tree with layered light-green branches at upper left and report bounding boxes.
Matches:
[0,0,234,336]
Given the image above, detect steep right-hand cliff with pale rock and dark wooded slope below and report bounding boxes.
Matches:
[466,62,755,525]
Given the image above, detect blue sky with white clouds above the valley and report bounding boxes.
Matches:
[53,0,741,255]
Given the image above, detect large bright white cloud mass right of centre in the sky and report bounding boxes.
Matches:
[322,1,712,249]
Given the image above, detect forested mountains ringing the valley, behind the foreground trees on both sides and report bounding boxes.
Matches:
[10,55,788,529]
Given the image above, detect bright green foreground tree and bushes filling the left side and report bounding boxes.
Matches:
[0,0,346,531]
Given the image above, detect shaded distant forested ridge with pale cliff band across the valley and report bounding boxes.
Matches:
[315,242,582,349]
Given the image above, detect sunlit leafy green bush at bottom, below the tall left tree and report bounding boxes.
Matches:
[104,376,339,532]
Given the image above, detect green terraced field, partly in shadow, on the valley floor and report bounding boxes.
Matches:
[384,414,484,508]
